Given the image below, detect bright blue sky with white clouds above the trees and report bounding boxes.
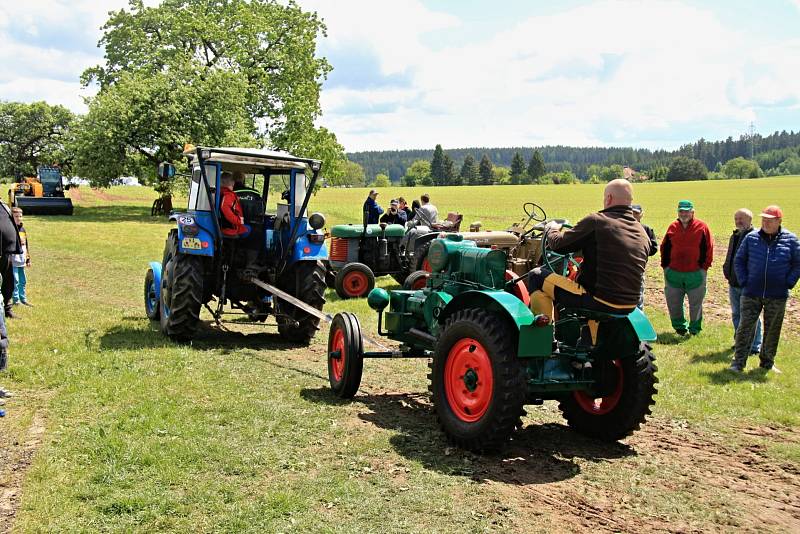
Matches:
[0,0,800,152]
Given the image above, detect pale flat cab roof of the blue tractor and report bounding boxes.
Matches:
[183,147,322,172]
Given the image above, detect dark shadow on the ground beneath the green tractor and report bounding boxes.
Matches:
[300,388,636,485]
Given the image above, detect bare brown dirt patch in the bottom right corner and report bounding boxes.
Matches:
[482,420,800,532]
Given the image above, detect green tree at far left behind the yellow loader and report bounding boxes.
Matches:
[0,102,75,176]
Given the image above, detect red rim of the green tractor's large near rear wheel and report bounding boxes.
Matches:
[444,338,494,423]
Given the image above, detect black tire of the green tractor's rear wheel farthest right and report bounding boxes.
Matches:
[559,343,658,441]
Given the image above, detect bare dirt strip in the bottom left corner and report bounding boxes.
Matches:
[0,410,46,532]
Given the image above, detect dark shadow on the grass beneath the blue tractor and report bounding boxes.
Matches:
[100,322,305,354]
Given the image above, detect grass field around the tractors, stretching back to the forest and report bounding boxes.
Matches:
[0,177,800,532]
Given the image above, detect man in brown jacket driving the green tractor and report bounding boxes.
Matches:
[526,179,650,317]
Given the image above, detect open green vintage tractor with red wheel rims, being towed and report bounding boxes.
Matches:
[328,234,658,451]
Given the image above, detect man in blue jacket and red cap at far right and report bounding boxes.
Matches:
[730,206,800,373]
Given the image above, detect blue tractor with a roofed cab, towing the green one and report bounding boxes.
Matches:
[144,147,328,344]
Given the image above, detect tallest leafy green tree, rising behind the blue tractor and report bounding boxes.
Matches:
[78,0,344,185]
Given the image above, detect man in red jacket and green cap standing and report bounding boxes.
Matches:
[661,200,714,335]
